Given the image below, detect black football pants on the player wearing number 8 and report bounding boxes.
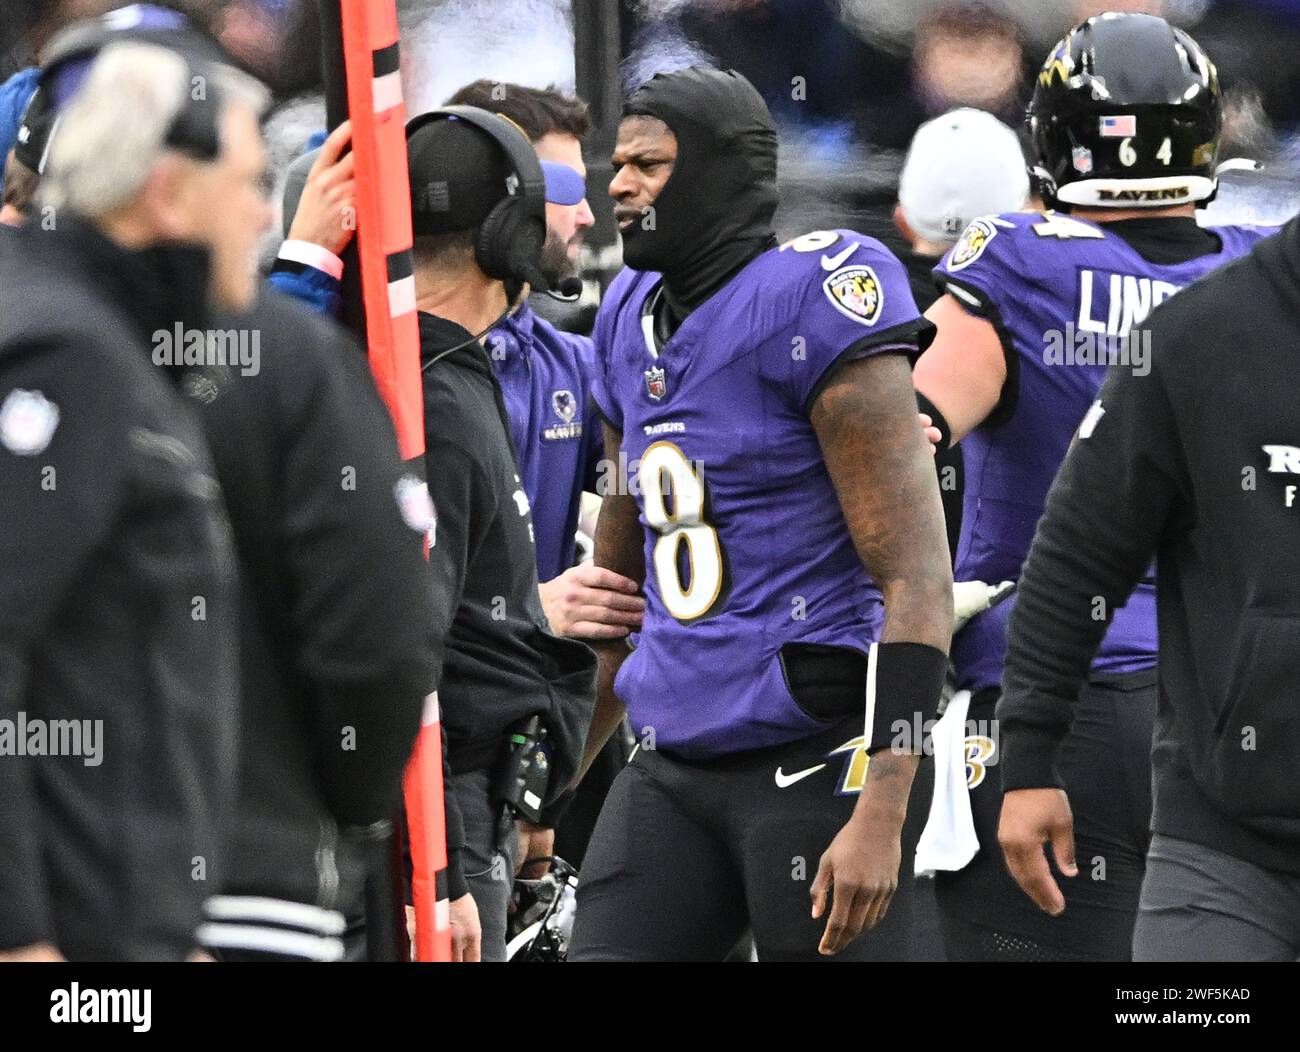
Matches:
[569,715,933,961]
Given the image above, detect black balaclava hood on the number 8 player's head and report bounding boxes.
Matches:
[623,69,777,320]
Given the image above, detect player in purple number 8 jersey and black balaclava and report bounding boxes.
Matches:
[571,69,952,961]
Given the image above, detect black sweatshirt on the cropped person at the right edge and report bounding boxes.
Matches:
[997,220,1300,874]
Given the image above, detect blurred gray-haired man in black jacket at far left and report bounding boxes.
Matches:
[0,34,268,960]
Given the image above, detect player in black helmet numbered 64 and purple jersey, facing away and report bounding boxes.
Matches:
[915,14,1271,961]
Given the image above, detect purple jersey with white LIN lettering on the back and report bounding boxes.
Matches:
[935,212,1274,690]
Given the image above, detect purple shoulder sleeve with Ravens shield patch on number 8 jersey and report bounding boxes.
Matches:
[763,231,933,411]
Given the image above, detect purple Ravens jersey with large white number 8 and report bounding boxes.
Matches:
[593,230,928,759]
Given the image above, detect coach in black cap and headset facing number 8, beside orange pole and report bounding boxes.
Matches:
[407,107,595,961]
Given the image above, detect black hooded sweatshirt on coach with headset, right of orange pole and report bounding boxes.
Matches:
[420,313,595,897]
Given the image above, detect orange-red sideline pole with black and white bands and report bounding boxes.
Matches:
[341,0,451,961]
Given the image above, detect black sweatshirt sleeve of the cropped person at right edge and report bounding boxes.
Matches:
[997,345,1191,789]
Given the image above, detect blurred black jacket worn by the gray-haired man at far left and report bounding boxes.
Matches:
[0,212,239,961]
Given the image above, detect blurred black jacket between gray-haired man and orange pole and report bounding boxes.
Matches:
[181,291,436,922]
